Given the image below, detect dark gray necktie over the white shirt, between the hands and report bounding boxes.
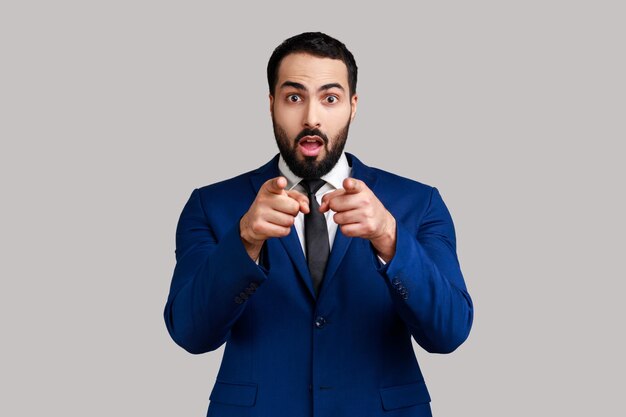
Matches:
[300,179,330,294]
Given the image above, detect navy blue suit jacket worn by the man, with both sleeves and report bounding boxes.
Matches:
[164,154,473,417]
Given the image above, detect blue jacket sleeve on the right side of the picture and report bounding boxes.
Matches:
[379,188,474,353]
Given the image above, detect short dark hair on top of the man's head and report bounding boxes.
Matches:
[267,32,357,97]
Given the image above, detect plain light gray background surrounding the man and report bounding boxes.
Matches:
[0,0,626,417]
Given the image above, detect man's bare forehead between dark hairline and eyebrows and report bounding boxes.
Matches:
[277,53,348,91]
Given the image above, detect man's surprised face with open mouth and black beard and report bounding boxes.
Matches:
[270,53,357,178]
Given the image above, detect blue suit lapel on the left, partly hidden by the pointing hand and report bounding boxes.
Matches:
[250,155,315,299]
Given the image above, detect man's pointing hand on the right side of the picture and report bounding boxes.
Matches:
[320,178,396,262]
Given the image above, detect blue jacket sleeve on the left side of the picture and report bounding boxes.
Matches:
[164,189,267,353]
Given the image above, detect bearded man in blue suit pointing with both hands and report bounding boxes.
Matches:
[164,33,473,417]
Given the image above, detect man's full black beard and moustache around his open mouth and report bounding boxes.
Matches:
[272,117,350,179]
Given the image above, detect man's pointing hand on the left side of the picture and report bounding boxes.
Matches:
[239,177,309,260]
